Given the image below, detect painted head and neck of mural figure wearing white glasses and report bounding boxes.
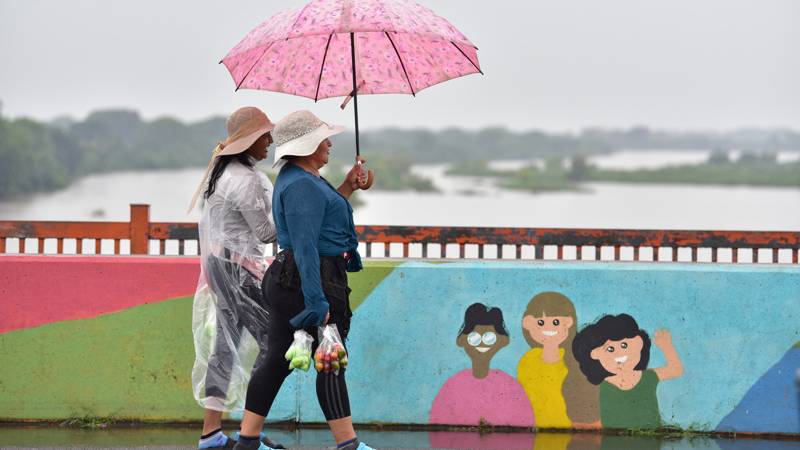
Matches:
[456,303,509,378]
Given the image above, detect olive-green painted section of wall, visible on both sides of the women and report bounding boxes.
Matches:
[0,262,397,420]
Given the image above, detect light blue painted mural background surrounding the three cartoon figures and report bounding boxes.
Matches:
[270,261,800,433]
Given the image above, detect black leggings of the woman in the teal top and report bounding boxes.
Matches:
[245,251,353,420]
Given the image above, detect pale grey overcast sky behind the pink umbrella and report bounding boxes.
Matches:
[0,0,800,130]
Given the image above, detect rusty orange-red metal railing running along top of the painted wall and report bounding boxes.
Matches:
[0,205,800,264]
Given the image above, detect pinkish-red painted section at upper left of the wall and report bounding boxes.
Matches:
[0,256,200,333]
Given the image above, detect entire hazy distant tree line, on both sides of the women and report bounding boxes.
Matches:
[0,106,800,198]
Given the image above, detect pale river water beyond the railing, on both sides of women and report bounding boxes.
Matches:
[0,151,800,231]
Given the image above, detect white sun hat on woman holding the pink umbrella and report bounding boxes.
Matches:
[272,110,345,167]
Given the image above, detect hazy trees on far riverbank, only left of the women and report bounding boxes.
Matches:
[0,110,225,198]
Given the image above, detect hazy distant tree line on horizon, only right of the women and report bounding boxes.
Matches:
[335,126,800,163]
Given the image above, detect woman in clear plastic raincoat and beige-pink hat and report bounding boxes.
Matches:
[190,107,283,449]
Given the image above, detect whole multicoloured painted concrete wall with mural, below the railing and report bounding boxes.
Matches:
[0,256,800,436]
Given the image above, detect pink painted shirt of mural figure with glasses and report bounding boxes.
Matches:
[429,369,534,427]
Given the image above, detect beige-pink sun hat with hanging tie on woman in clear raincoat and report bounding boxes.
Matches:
[189,106,275,212]
